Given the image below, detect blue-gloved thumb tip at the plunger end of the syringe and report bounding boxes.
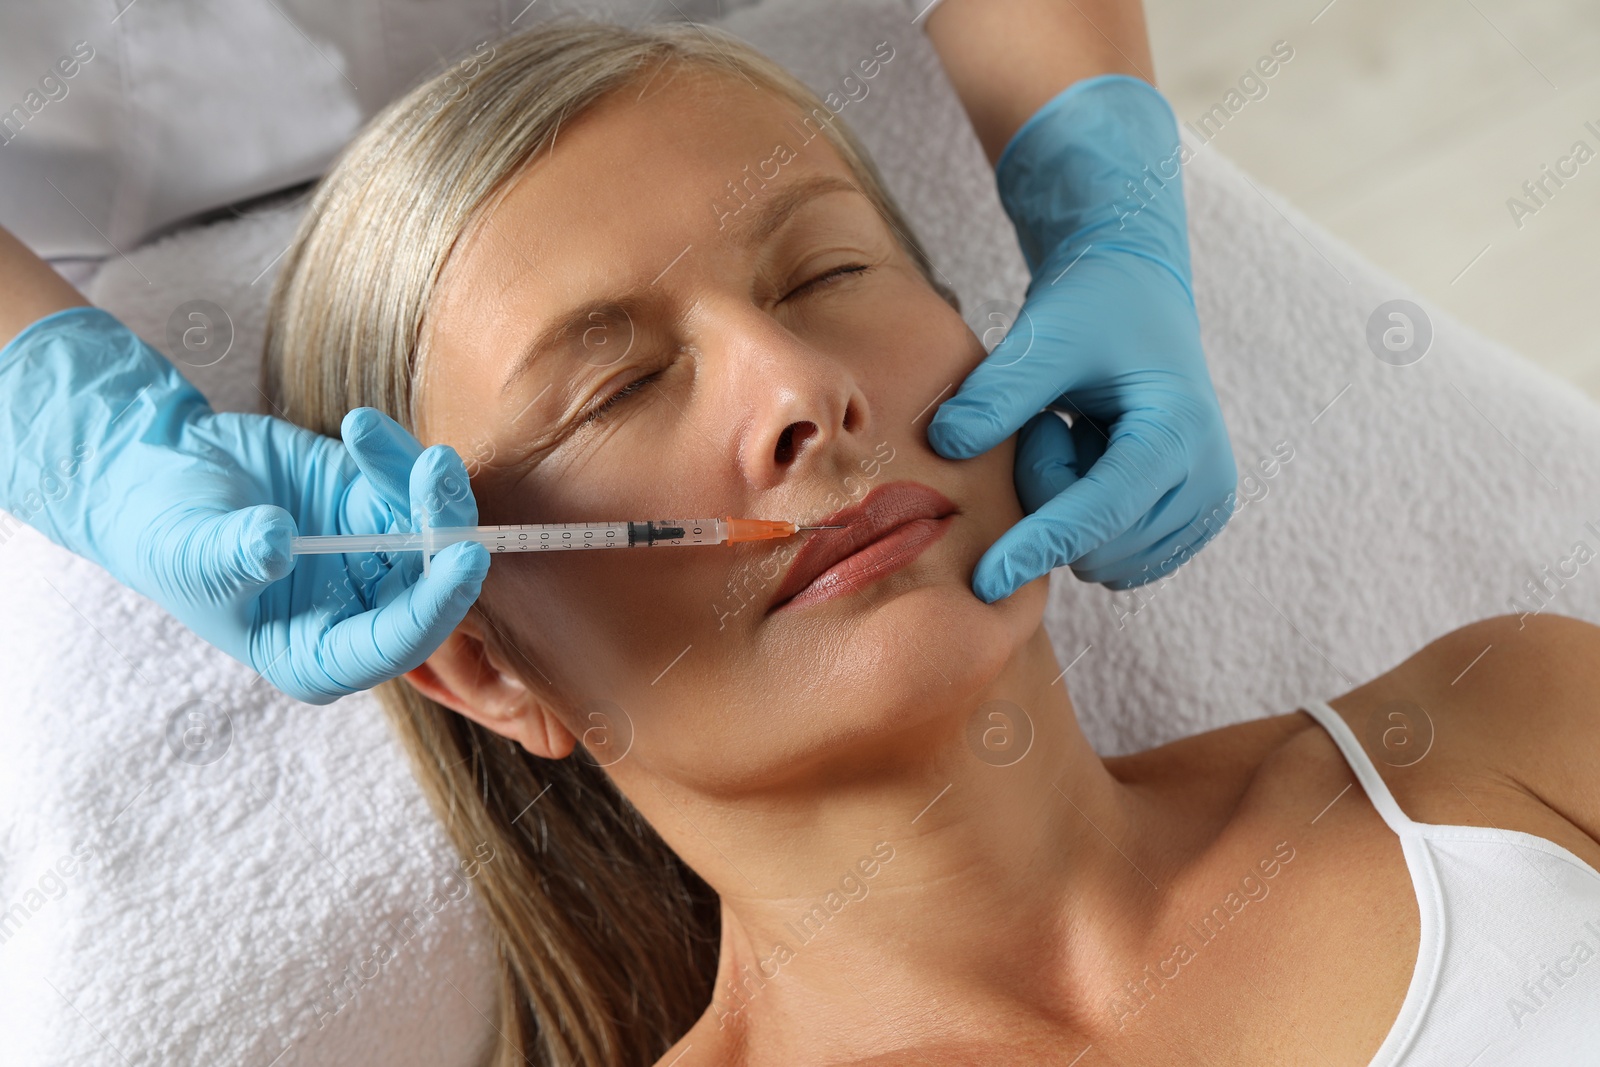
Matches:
[146,504,296,605]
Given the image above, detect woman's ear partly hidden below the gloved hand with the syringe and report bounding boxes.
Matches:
[403,611,578,760]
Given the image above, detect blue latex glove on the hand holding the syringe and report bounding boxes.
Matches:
[0,307,490,704]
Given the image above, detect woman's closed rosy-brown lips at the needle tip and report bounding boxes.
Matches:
[768,482,957,613]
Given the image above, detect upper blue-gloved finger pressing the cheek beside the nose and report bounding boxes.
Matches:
[928,298,1088,459]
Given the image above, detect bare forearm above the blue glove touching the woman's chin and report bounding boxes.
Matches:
[923,0,1154,165]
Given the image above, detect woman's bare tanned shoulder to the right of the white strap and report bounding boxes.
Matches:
[1330,614,1600,849]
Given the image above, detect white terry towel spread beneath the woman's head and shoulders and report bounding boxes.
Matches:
[0,0,1600,1067]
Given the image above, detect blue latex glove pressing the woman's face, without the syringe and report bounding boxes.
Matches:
[928,75,1238,603]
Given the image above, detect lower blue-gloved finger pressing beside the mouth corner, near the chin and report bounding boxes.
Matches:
[973,413,1184,603]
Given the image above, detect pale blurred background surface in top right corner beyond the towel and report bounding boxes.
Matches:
[1146,0,1600,400]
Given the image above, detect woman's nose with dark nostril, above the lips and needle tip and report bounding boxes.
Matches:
[738,320,867,490]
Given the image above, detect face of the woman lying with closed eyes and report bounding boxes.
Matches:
[419,66,1046,792]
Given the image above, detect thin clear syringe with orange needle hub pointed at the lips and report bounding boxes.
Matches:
[290,517,843,573]
